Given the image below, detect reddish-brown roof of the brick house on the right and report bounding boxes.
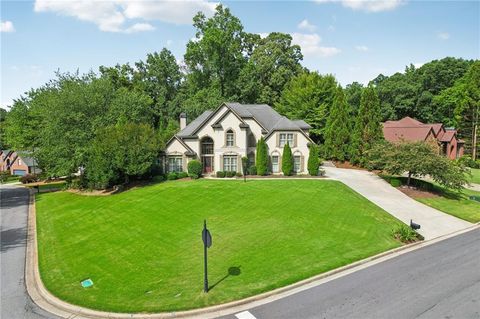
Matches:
[383,116,457,142]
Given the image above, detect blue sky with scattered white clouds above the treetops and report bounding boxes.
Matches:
[0,0,480,108]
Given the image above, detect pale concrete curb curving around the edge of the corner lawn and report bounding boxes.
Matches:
[25,190,480,319]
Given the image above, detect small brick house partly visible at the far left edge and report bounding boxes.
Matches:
[0,150,41,176]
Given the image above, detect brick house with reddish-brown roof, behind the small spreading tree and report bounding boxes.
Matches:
[383,116,464,159]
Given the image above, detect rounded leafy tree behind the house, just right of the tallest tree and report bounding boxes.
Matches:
[238,32,303,105]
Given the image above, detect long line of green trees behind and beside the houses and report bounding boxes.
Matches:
[0,5,480,187]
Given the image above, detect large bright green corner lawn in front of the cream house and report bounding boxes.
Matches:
[37,180,401,312]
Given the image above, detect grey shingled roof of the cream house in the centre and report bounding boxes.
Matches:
[177,102,311,138]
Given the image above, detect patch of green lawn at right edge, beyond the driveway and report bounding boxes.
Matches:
[416,186,480,223]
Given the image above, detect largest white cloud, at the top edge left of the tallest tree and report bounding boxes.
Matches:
[34,0,217,33]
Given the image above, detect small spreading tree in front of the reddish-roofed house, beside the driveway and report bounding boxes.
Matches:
[367,142,467,190]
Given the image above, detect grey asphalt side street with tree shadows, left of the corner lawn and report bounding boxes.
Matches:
[0,185,57,319]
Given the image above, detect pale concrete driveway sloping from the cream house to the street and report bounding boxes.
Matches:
[324,167,473,240]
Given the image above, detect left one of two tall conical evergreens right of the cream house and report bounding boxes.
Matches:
[324,86,351,161]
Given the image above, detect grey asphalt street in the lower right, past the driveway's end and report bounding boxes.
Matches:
[223,229,480,319]
